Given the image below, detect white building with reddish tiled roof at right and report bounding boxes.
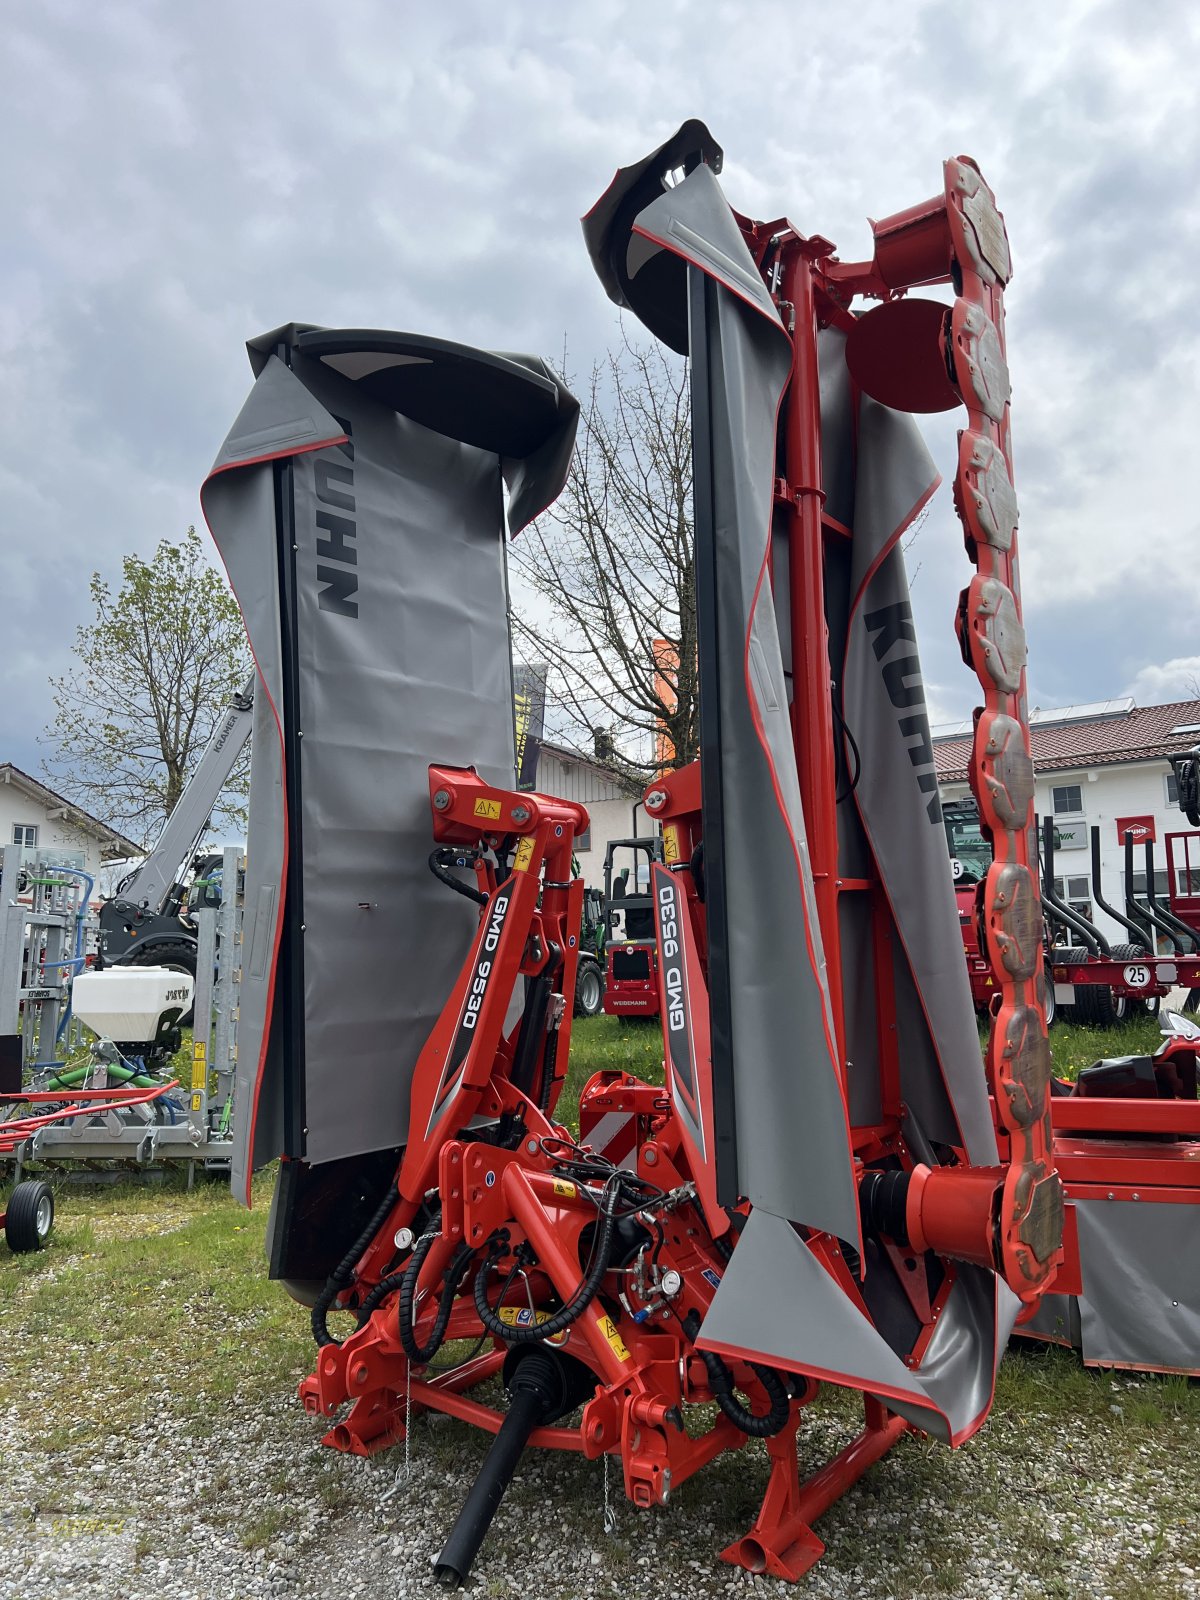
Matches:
[933,698,1200,939]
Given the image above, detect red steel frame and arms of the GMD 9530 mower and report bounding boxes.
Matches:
[301,162,1061,1579]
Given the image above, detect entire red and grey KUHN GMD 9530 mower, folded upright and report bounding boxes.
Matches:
[203,122,1083,1584]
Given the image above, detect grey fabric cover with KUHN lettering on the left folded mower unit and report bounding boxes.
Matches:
[202,326,578,1195]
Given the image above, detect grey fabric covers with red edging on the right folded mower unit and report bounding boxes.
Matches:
[584,123,1016,1440]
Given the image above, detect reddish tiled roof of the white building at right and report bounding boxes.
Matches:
[933,699,1200,784]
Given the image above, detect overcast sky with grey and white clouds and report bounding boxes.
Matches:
[0,0,1200,770]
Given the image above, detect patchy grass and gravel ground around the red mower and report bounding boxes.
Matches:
[0,1018,1200,1600]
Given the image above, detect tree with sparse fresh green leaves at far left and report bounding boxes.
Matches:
[42,528,250,845]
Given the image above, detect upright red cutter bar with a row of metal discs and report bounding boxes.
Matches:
[946,157,1062,1296]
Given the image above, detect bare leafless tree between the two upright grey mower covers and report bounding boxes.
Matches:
[512,339,699,790]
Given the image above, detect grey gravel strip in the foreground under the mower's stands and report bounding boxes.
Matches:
[0,1337,1200,1600]
